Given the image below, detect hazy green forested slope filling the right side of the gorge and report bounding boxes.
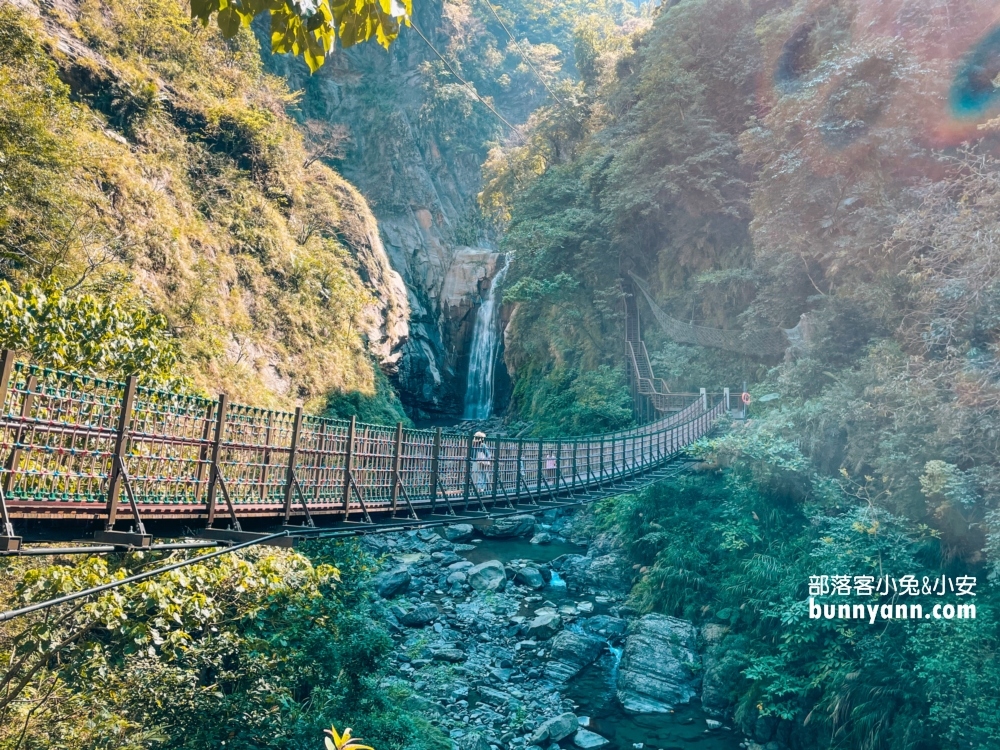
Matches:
[498,0,1000,750]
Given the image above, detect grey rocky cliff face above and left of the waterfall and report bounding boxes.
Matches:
[268,0,561,417]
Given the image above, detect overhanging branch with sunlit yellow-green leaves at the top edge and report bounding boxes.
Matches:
[191,0,413,73]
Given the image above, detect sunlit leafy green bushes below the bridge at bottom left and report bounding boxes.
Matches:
[0,542,446,750]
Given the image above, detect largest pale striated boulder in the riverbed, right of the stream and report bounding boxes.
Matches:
[617,614,696,714]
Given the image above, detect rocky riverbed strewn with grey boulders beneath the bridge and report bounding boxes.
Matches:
[365,512,764,750]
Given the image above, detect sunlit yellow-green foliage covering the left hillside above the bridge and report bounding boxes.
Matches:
[0,0,396,407]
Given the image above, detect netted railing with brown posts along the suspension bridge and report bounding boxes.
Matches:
[0,352,726,528]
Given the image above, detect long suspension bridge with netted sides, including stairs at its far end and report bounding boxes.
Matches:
[0,276,752,555]
